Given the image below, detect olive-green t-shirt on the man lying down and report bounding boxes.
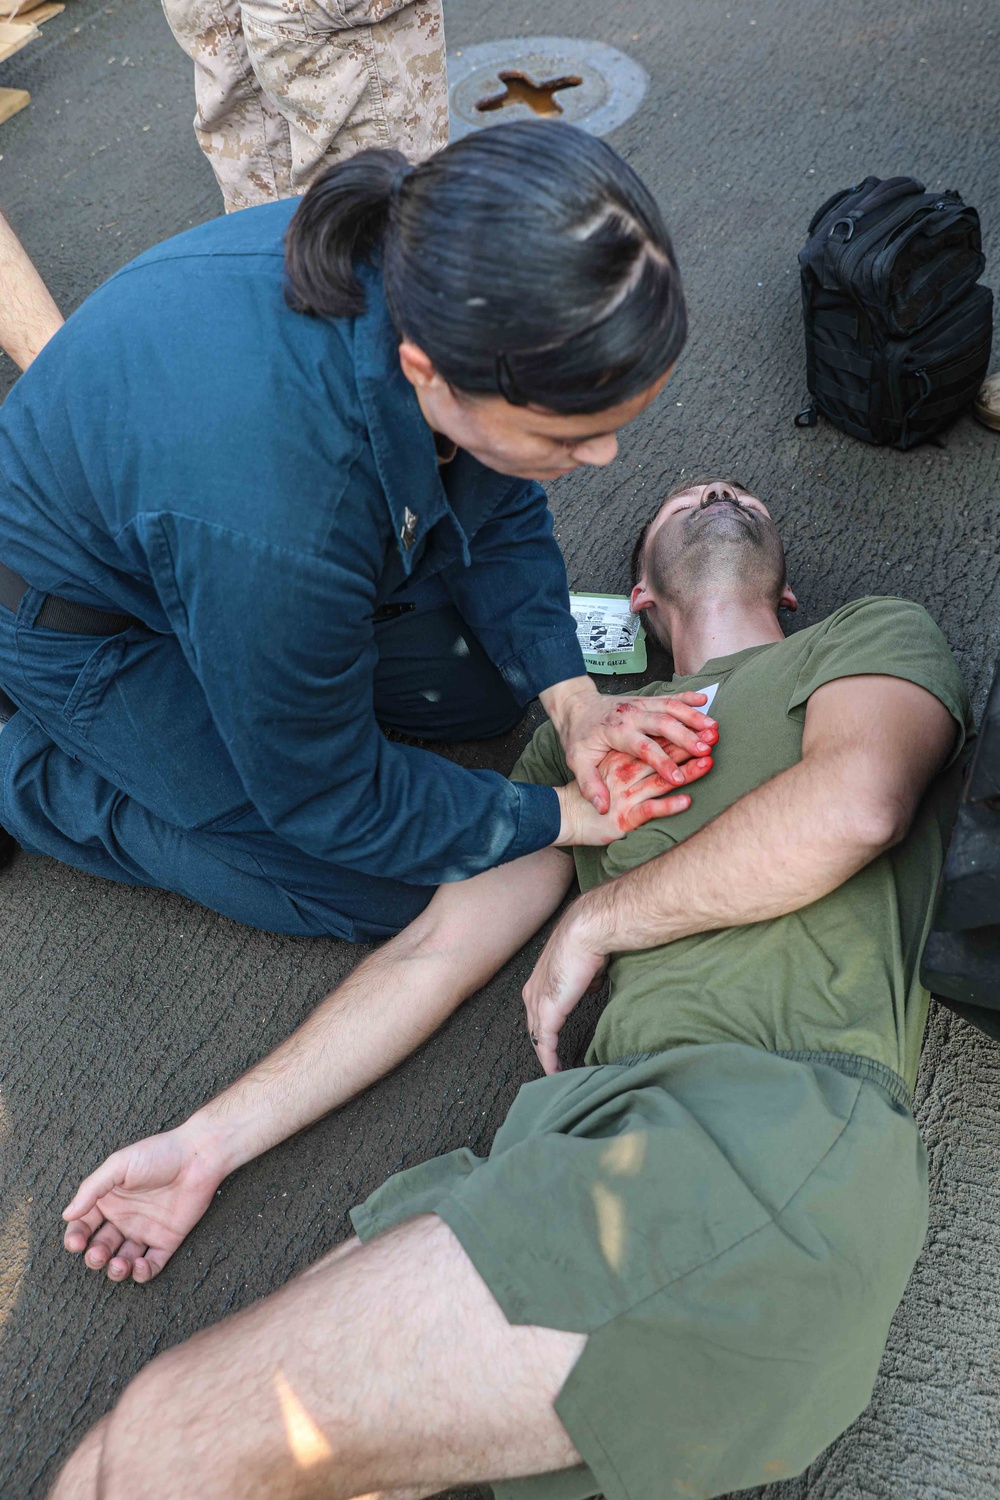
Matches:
[513,599,972,1088]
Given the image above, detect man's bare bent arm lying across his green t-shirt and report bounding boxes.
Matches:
[525,677,957,1073]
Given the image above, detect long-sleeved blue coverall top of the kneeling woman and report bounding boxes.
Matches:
[0,201,585,884]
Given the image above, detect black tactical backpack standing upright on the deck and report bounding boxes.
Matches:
[795,177,993,449]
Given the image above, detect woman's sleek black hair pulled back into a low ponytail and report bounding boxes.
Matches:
[285,122,687,414]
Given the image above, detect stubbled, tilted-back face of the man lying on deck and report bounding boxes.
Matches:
[631,480,795,647]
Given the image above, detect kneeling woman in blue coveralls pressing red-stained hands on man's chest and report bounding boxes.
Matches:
[0,123,714,939]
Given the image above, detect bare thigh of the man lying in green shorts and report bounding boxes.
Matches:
[52,1217,586,1500]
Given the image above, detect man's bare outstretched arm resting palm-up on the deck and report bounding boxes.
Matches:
[63,849,573,1281]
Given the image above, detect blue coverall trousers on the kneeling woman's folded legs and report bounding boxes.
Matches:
[0,578,523,942]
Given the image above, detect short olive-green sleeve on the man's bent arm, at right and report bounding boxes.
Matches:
[789,599,973,765]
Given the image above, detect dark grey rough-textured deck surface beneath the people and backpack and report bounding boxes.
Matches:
[0,0,1000,1500]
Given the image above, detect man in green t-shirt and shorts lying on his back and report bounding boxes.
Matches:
[55,482,970,1500]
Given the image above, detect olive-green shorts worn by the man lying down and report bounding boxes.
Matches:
[352,1043,927,1500]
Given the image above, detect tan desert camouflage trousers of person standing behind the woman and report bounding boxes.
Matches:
[163,0,448,213]
